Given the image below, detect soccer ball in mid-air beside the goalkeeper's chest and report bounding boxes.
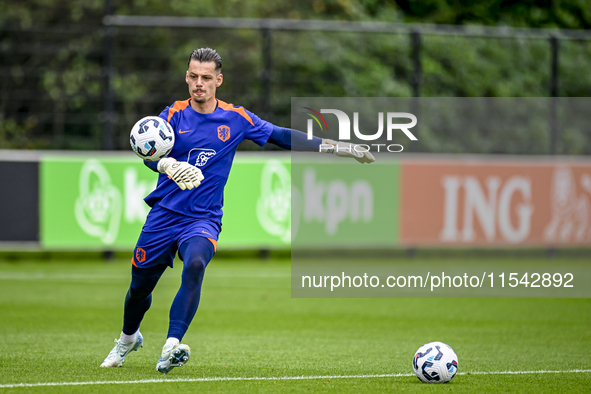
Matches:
[129,116,174,161]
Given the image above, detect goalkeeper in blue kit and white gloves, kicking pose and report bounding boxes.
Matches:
[101,48,375,374]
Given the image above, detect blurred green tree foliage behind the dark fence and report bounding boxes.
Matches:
[0,0,591,154]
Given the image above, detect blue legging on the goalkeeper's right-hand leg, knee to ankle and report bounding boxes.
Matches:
[168,237,215,341]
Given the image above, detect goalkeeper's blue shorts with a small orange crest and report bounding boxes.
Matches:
[131,204,221,268]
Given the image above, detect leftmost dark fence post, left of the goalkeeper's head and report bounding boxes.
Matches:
[99,0,115,150]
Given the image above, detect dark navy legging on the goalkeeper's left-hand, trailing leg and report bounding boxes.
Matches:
[123,264,167,335]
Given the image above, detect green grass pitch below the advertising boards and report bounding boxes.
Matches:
[0,256,591,393]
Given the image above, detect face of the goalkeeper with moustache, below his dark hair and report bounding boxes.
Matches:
[185,60,223,104]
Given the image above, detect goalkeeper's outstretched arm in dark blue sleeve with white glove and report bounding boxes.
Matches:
[267,125,376,163]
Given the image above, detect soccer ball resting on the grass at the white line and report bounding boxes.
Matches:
[412,342,458,383]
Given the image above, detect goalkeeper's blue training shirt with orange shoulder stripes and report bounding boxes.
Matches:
[144,99,273,225]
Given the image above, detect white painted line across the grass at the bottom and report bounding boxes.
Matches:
[0,369,591,388]
